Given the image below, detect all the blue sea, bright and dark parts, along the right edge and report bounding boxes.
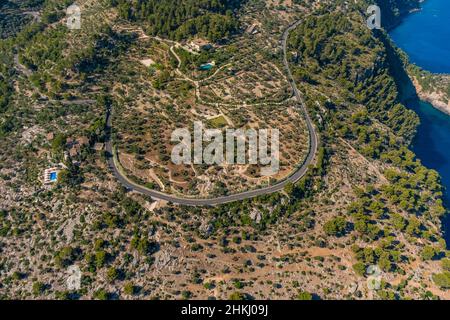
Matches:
[390,0,450,242]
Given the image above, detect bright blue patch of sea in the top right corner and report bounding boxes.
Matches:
[390,0,450,73]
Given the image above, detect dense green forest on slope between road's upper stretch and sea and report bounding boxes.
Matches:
[290,14,419,141]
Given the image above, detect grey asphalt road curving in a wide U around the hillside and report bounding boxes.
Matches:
[105,21,319,206]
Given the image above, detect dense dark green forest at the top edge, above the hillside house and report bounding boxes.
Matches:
[111,0,243,42]
